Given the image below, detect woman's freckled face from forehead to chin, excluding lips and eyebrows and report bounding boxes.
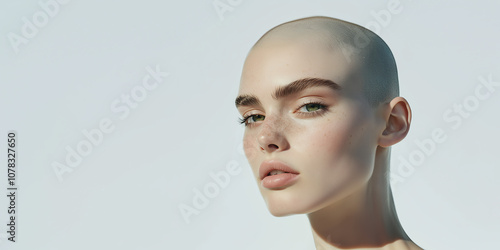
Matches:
[238,35,382,216]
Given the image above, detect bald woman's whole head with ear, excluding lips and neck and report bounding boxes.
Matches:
[236,17,411,216]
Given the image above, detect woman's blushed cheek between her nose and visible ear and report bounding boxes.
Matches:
[298,112,375,183]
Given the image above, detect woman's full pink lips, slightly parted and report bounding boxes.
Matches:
[259,160,299,189]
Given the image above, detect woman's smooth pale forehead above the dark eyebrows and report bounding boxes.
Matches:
[239,38,360,94]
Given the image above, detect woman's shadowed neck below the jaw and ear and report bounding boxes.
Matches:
[308,147,416,249]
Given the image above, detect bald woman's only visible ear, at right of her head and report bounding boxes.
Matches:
[378,96,411,147]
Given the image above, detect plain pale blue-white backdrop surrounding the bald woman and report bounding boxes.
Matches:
[0,0,500,250]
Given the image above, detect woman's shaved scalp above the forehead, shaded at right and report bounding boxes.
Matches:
[250,16,399,106]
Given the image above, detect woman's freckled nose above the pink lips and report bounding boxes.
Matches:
[257,116,290,153]
